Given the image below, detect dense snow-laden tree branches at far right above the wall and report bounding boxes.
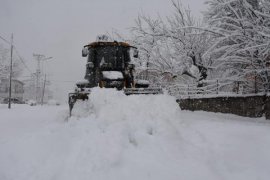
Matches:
[204,0,270,93]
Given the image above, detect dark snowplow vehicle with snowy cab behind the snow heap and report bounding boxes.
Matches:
[68,36,162,116]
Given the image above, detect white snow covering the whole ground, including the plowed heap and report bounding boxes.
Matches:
[0,89,270,180]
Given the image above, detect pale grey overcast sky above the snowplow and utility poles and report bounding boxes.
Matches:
[0,0,206,101]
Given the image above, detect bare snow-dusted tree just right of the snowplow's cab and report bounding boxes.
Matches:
[132,1,211,86]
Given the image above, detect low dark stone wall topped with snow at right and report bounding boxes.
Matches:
[177,96,270,119]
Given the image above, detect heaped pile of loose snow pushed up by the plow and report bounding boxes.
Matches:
[70,88,180,136]
